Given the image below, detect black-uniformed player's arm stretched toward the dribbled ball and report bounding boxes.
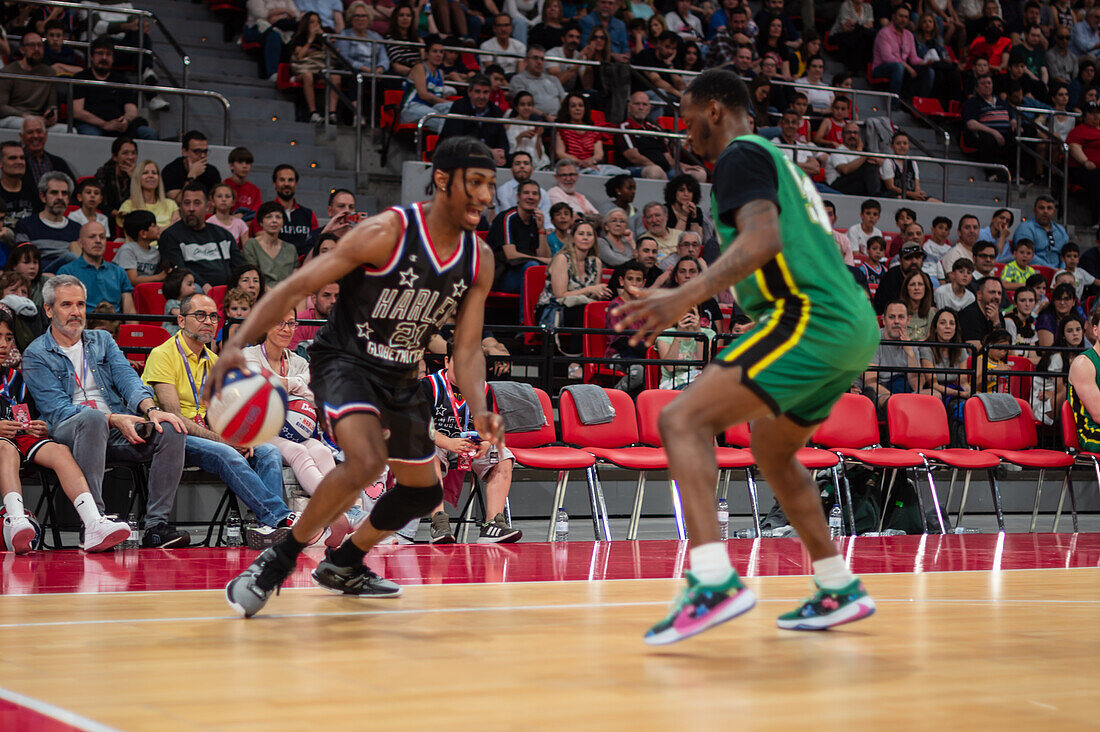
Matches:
[202,211,402,402]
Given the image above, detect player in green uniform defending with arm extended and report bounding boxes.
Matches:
[616,69,879,645]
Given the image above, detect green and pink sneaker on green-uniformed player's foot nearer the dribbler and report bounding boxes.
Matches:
[645,570,756,645]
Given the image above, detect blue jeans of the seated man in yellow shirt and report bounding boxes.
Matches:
[184,435,290,526]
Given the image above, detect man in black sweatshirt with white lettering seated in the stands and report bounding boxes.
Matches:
[158,182,244,293]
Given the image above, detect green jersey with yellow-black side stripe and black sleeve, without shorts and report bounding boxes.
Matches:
[711,134,878,375]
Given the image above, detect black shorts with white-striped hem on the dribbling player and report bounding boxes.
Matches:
[309,345,436,462]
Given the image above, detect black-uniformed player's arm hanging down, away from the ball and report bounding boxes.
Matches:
[454,241,504,447]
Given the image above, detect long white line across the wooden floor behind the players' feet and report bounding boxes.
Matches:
[0,586,1100,630]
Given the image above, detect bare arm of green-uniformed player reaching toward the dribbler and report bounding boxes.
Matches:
[615,199,783,346]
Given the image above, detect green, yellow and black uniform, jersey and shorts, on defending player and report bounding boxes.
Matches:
[711,134,879,425]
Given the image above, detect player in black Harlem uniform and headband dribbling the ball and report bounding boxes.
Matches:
[206,138,504,618]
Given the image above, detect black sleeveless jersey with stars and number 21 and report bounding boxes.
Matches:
[310,204,480,379]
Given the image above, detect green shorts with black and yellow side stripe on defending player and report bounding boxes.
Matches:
[715,308,879,426]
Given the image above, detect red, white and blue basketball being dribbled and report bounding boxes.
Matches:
[207,369,287,447]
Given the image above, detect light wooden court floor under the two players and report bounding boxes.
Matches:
[0,568,1100,730]
